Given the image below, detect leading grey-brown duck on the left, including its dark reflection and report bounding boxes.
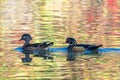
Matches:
[19,34,53,62]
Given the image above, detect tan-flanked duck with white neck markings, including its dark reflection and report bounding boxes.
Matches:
[66,37,103,60]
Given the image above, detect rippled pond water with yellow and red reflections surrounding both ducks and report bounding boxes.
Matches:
[0,0,120,80]
